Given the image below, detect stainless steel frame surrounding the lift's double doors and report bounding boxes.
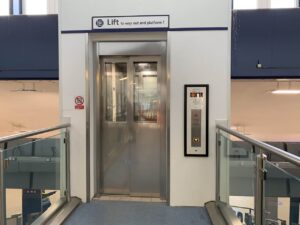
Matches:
[94,41,169,200]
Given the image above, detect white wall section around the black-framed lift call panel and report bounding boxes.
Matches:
[169,31,229,205]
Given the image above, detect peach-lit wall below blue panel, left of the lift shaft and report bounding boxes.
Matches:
[0,80,60,136]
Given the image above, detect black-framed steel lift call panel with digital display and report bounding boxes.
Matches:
[184,85,208,156]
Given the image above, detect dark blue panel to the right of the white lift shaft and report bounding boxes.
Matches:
[231,8,300,78]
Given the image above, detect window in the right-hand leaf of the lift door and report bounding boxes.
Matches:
[133,62,159,123]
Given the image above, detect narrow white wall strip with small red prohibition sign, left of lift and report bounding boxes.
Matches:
[60,34,86,201]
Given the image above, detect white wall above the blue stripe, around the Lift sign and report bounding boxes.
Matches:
[60,0,230,30]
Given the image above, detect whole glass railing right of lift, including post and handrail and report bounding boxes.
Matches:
[216,125,300,225]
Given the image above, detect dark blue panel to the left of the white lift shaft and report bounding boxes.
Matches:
[0,15,58,80]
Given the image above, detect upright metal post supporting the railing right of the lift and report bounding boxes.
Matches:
[254,152,267,225]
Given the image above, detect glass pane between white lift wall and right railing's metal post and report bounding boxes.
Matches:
[218,131,256,225]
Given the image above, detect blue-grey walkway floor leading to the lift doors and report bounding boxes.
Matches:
[64,200,211,225]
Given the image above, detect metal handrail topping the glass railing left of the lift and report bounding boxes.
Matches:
[0,123,71,144]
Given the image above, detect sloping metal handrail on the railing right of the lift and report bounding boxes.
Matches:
[216,124,300,167]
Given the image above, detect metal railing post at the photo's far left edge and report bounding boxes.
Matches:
[0,149,6,225]
